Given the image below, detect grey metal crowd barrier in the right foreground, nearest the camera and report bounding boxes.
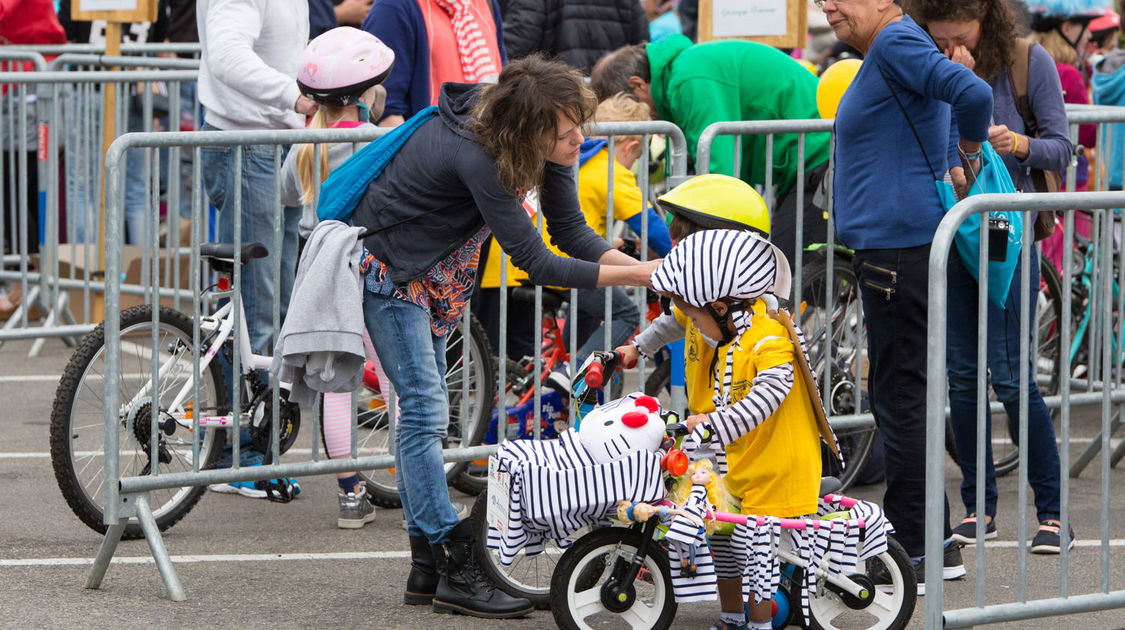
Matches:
[925,191,1125,629]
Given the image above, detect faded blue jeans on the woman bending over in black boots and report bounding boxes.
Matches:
[363,291,458,545]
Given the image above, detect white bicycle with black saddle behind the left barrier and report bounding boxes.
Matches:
[51,243,493,539]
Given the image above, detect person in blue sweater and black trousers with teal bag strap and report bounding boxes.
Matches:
[818,0,992,592]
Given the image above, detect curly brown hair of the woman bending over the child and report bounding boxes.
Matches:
[473,54,597,191]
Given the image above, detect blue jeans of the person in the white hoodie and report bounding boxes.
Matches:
[200,125,300,354]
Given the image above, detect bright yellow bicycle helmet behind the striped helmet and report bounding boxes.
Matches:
[657,173,770,239]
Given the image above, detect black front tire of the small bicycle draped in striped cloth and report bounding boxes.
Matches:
[550,528,678,630]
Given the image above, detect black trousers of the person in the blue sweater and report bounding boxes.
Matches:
[852,244,952,557]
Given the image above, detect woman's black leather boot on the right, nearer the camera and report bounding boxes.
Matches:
[433,519,533,619]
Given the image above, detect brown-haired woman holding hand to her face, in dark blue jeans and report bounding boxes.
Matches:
[910,0,1073,554]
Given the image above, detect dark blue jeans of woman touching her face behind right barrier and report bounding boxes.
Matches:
[945,250,1060,521]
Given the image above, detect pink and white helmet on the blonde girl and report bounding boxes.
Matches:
[297,26,395,105]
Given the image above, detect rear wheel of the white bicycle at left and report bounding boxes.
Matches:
[51,305,228,539]
